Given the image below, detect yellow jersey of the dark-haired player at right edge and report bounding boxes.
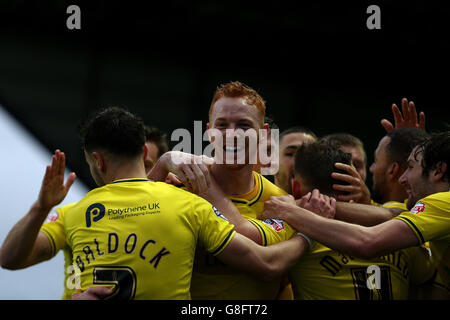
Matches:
[395,190,450,292]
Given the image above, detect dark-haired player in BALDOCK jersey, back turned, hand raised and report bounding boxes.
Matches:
[0,107,307,299]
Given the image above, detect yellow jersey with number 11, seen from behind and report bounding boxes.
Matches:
[289,242,435,300]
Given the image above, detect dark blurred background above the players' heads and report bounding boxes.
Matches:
[0,0,450,187]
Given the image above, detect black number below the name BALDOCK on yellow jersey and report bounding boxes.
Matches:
[94,266,136,300]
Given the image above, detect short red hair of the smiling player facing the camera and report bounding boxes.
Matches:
[209,81,266,123]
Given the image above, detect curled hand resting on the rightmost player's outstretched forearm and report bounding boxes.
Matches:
[297,189,336,219]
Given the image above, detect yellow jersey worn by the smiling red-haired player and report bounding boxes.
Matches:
[191,172,296,300]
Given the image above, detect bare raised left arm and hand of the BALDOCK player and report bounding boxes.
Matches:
[0,150,76,269]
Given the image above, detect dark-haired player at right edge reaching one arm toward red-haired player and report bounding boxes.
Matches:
[264,131,450,299]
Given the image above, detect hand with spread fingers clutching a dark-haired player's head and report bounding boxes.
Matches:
[331,162,370,204]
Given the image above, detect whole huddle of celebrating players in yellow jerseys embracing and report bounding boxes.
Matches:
[0,82,450,300]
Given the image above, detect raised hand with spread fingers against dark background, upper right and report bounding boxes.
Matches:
[381,98,425,132]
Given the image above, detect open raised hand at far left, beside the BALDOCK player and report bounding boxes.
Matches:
[37,150,76,210]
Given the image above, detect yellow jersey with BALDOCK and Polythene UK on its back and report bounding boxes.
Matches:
[65,179,235,300]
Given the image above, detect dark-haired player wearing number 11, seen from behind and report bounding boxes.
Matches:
[289,140,435,300]
